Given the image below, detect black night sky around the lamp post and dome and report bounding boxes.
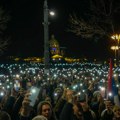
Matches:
[1,0,119,58]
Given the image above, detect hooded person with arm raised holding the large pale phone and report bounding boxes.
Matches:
[20,88,56,120]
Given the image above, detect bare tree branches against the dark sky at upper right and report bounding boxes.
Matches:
[68,0,120,38]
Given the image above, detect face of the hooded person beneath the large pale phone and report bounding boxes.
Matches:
[42,104,52,119]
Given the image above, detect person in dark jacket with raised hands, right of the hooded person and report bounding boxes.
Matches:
[59,89,84,120]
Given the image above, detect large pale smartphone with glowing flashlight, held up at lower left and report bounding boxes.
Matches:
[29,86,40,107]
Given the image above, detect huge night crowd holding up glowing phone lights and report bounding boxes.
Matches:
[0,62,120,120]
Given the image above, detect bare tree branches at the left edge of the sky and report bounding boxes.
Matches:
[0,7,10,55]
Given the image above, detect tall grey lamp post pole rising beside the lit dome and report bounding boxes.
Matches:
[43,0,50,75]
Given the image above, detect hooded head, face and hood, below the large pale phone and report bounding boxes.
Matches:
[37,101,52,119]
